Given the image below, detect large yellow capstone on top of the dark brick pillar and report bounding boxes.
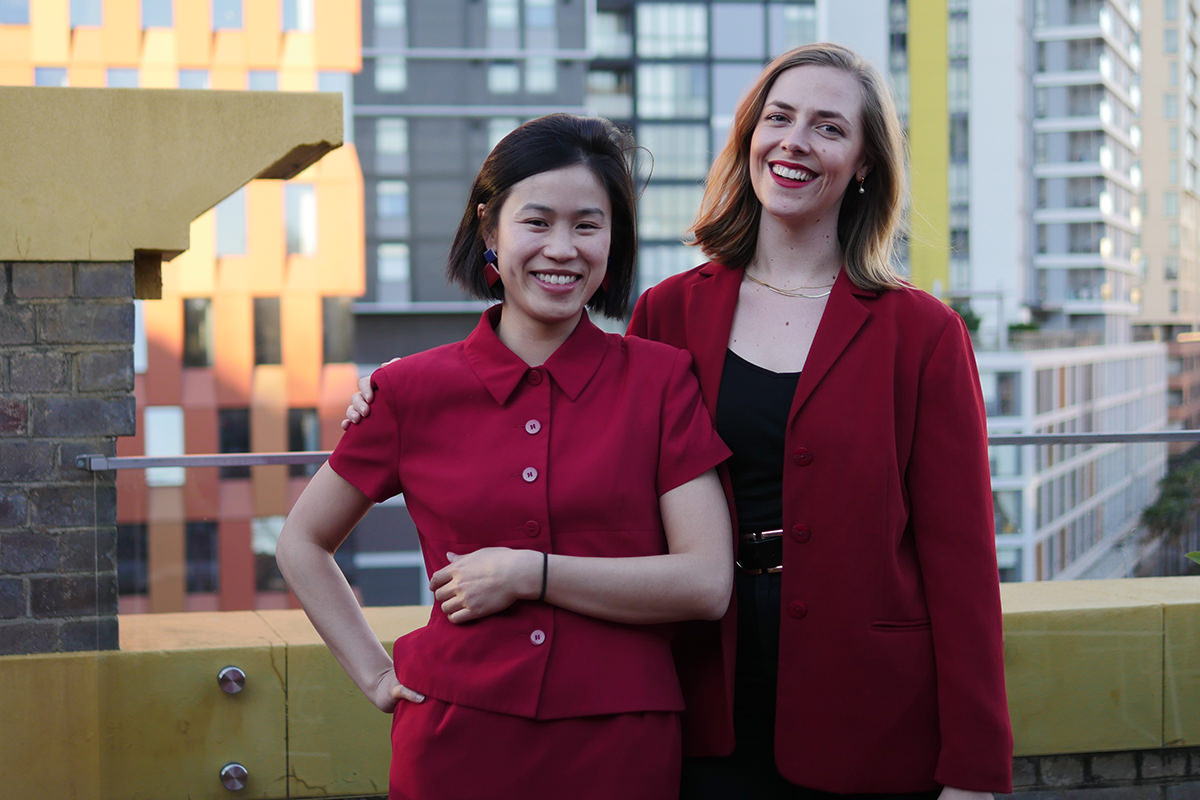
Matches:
[0,86,343,293]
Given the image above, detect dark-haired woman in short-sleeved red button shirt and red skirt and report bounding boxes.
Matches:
[277,114,732,800]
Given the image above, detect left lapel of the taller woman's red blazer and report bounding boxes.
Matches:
[684,261,742,415]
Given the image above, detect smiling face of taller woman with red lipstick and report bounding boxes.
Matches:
[749,65,869,234]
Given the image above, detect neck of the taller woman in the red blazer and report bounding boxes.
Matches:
[746,213,844,287]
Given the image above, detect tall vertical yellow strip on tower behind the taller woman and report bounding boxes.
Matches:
[907,0,950,294]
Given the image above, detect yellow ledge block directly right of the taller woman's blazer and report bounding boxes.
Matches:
[1002,582,1163,756]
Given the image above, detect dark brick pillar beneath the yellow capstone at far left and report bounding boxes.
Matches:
[0,261,134,655]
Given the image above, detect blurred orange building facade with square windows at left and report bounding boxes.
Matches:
[0,0,364,613]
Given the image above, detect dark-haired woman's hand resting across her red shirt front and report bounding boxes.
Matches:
[430,547,541,622]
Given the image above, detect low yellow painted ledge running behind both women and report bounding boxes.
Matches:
[0,578,1200,800]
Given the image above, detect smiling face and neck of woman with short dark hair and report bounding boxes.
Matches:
[479,164,612,347]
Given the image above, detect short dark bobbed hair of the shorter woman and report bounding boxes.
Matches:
[446,114,637,318]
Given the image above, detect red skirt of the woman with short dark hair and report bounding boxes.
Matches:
[388,697,682,800]
